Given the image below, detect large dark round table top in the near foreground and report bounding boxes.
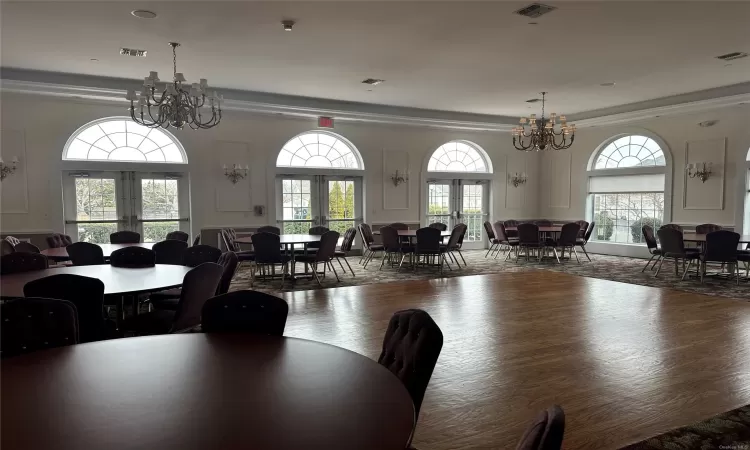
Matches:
[1,333,414,450]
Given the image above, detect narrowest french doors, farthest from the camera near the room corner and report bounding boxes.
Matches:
[427,179,489,248]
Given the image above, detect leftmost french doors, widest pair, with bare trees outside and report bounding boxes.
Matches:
[63,172,190,244]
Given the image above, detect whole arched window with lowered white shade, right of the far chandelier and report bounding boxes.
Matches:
[589,134,669,244]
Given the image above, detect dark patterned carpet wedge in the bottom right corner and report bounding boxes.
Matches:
[621,405,750,450]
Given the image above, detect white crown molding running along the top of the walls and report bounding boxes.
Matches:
[0,68,750,132]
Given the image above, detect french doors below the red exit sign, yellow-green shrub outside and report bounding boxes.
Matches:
[276,175,362,236]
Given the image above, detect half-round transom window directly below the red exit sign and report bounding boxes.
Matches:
[276,131,364,169]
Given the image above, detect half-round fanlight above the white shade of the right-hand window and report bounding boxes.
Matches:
[594,135,666,169]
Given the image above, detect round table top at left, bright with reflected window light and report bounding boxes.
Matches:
[0,264,191,297]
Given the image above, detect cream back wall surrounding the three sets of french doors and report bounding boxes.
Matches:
[0,93,541,237]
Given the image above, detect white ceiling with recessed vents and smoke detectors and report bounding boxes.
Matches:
[0,1,750,116]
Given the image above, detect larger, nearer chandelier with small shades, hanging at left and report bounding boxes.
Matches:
[125,42,223,130]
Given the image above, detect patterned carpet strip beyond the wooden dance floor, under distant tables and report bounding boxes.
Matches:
[232,250,750,300]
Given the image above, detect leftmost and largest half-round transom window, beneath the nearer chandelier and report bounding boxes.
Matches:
[63,117,187,164]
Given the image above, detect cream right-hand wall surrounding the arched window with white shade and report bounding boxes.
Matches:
[540,105,750,255]
